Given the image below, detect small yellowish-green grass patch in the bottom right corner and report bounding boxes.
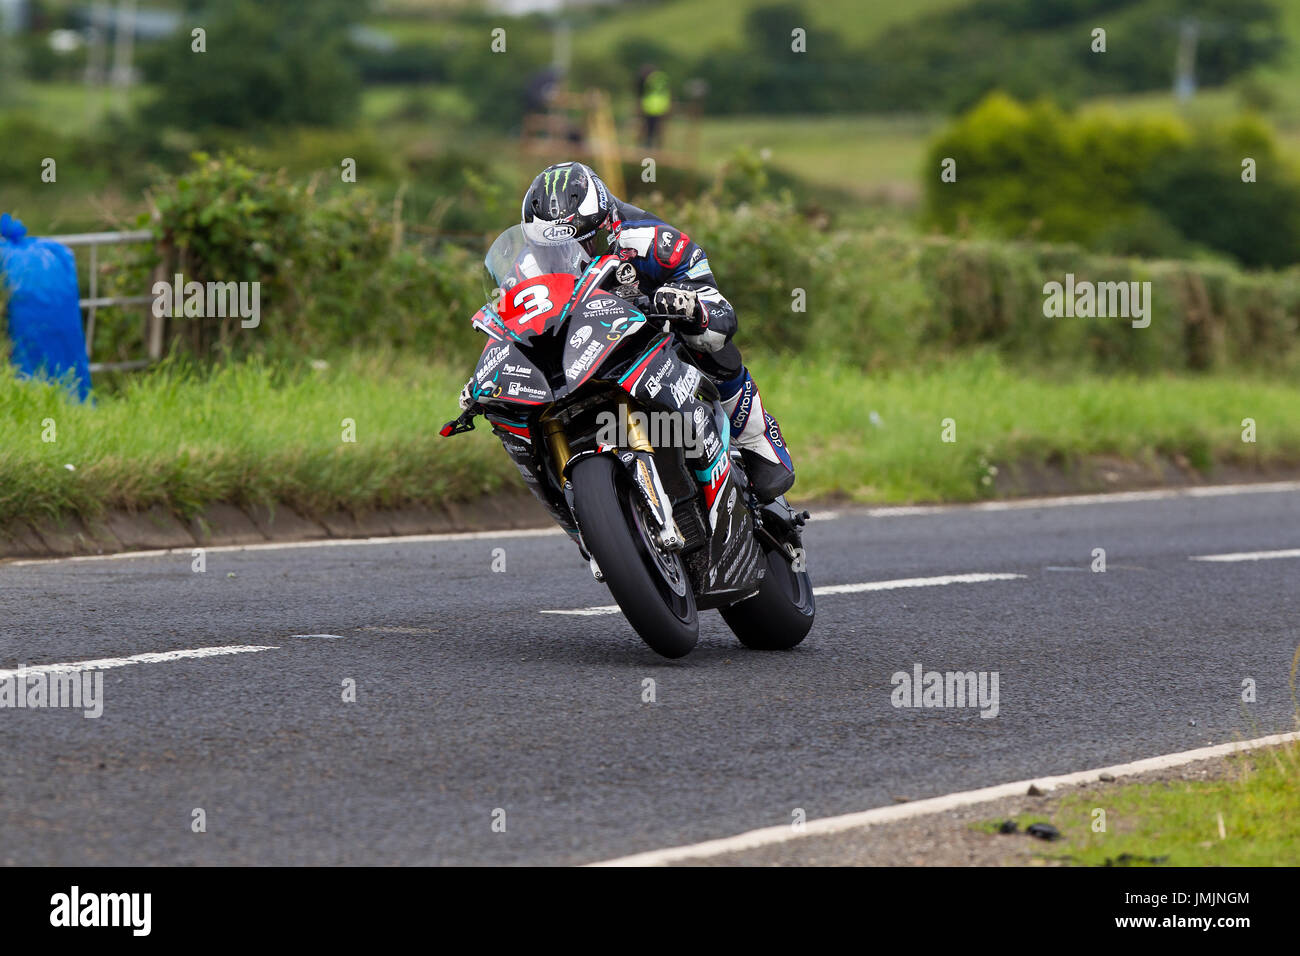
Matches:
[979,744,1300,866]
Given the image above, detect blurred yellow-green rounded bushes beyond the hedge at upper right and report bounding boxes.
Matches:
[926,94,1300,267]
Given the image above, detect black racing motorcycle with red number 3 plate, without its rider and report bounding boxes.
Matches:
[441,224,814,658]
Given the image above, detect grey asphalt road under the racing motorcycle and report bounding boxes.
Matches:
[0,490,1300,865]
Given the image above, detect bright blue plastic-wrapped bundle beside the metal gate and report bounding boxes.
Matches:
[0,213,90,402]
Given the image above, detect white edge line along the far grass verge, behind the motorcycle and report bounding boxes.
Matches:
[0,481,1300,568]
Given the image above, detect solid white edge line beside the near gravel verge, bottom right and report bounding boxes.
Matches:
[588,732,1300,866]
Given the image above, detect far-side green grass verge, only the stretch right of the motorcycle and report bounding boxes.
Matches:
[751,355,1300,502]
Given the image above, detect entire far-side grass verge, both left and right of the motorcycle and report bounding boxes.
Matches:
[0,355,1300,523]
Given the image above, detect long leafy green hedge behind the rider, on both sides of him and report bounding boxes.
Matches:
[98,156,1300,372]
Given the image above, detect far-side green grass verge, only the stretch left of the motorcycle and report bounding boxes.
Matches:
[0,358,514,522]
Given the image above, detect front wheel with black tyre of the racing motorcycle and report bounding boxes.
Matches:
[571,455,699,658]
